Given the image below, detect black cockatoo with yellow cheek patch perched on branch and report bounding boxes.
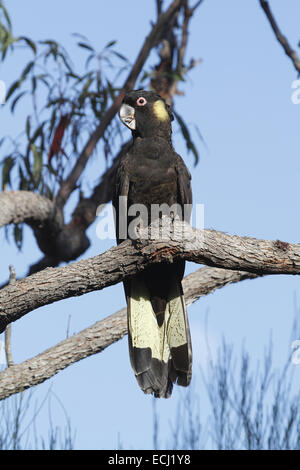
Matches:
[113,90,192,398]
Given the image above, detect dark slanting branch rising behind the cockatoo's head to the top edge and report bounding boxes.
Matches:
[56,0,182,207]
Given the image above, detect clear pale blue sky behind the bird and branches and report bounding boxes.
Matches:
[0,0,300,449]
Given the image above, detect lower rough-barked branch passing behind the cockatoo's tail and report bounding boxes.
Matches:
[0,267,257,400]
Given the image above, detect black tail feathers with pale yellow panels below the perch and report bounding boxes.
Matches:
[127,278,192,398]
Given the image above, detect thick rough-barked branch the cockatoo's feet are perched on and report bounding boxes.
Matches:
[0,221,300,333]
